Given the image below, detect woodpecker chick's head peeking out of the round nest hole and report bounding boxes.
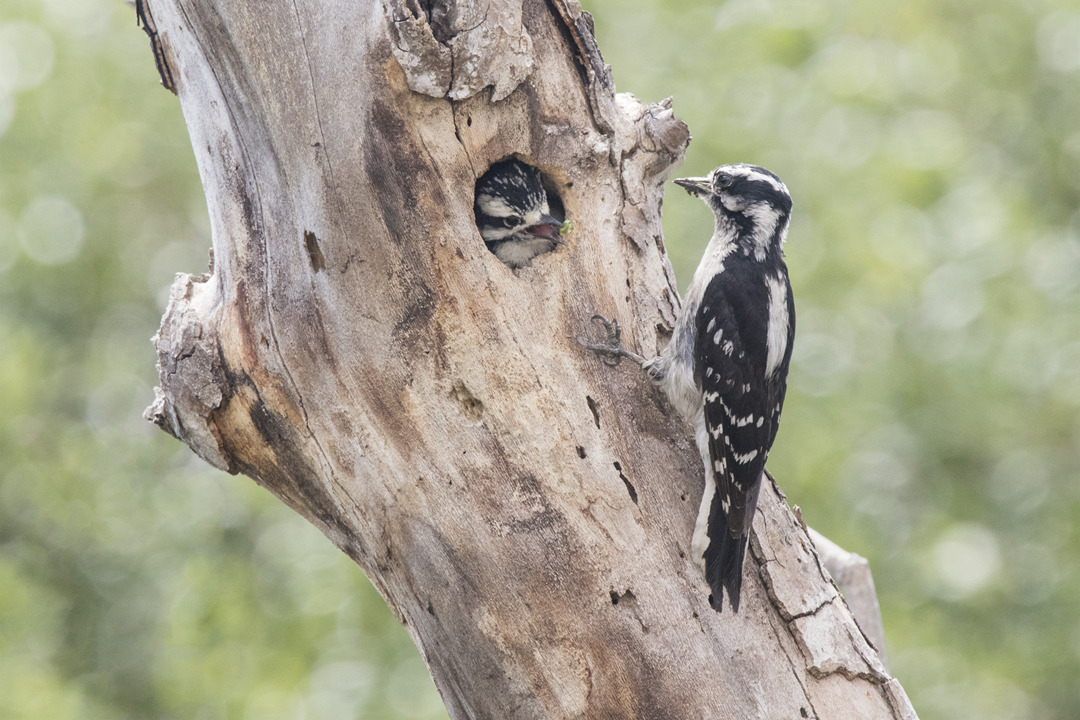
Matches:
[474,160,564,268]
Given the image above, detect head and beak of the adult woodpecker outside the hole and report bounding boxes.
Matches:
[675,163,792,260]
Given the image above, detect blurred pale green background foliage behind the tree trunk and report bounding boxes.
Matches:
[0,0,1080,720]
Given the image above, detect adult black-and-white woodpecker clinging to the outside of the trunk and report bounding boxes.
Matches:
[579,164,795,612]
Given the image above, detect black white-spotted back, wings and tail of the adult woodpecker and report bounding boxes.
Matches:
[694,255,794,611]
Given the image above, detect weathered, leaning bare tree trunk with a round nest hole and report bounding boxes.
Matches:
[144,0,915,719]
